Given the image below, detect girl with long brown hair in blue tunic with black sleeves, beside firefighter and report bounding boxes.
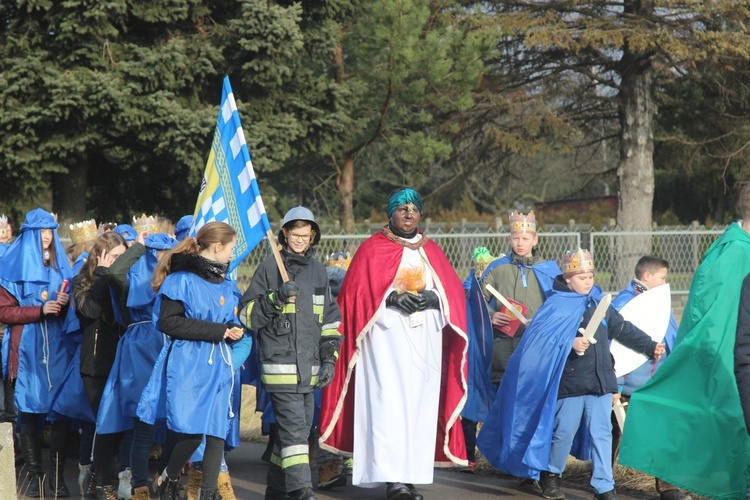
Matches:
[137,222,247,500]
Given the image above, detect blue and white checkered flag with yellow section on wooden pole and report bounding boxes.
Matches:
[190,77,271,271]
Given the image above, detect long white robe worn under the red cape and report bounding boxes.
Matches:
[352,240,446,487]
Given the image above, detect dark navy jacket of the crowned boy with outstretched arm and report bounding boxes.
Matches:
[553,276,657,399]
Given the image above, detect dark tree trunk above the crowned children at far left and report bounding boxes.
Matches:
[52,159,88,226]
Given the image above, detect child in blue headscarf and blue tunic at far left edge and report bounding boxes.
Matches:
[0,208,73,497]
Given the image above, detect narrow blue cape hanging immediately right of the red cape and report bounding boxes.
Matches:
[461,270,497,422]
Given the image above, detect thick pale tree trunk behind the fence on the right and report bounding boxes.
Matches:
[611,50,656,290]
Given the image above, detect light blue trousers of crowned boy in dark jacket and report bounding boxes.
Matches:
[549,394,615,493]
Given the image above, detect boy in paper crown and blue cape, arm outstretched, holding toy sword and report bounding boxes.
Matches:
[477,249,664,500]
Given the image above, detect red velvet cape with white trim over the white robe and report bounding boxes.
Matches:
[320,233,468,467]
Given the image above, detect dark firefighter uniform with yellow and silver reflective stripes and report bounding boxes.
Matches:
[240,248,341,498]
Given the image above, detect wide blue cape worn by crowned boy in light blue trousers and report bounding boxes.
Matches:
[477,286,602,479]
